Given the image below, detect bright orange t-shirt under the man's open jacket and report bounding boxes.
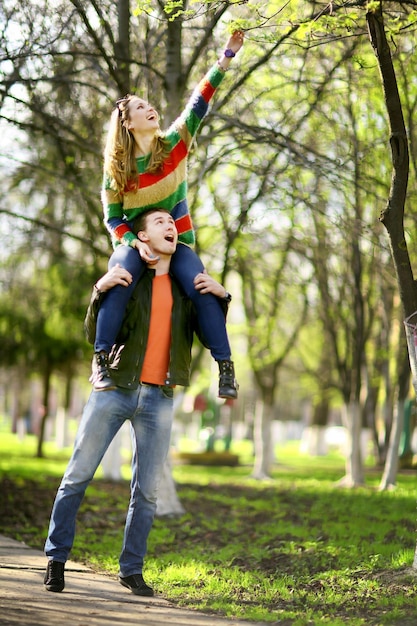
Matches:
[140,274,173,385]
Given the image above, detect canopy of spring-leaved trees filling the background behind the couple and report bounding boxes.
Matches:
[0,0,417,478]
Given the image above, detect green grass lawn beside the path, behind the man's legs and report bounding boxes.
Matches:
[0,426,417,626]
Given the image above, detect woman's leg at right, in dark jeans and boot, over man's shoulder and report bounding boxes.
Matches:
[171,244,237,398]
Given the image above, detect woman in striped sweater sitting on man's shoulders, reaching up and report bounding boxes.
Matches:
[93,31,243,398]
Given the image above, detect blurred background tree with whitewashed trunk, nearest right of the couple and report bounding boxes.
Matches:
[234,222,308,479]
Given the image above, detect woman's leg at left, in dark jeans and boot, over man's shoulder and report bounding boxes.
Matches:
[93,245,145,391]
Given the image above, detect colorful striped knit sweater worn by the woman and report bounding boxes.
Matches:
[102,64,224,246]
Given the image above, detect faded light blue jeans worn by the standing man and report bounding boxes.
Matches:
[45,385,173,577]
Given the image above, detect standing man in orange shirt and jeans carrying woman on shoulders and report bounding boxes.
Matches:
[44,209,229,596]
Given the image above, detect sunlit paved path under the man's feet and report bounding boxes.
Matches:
[0,535,266,626]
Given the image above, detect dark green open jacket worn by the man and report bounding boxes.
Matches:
[84,269,227,389]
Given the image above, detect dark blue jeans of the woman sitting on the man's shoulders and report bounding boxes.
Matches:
[94,243,231,361]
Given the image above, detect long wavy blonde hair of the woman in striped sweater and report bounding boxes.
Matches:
[104,94,170,193]
